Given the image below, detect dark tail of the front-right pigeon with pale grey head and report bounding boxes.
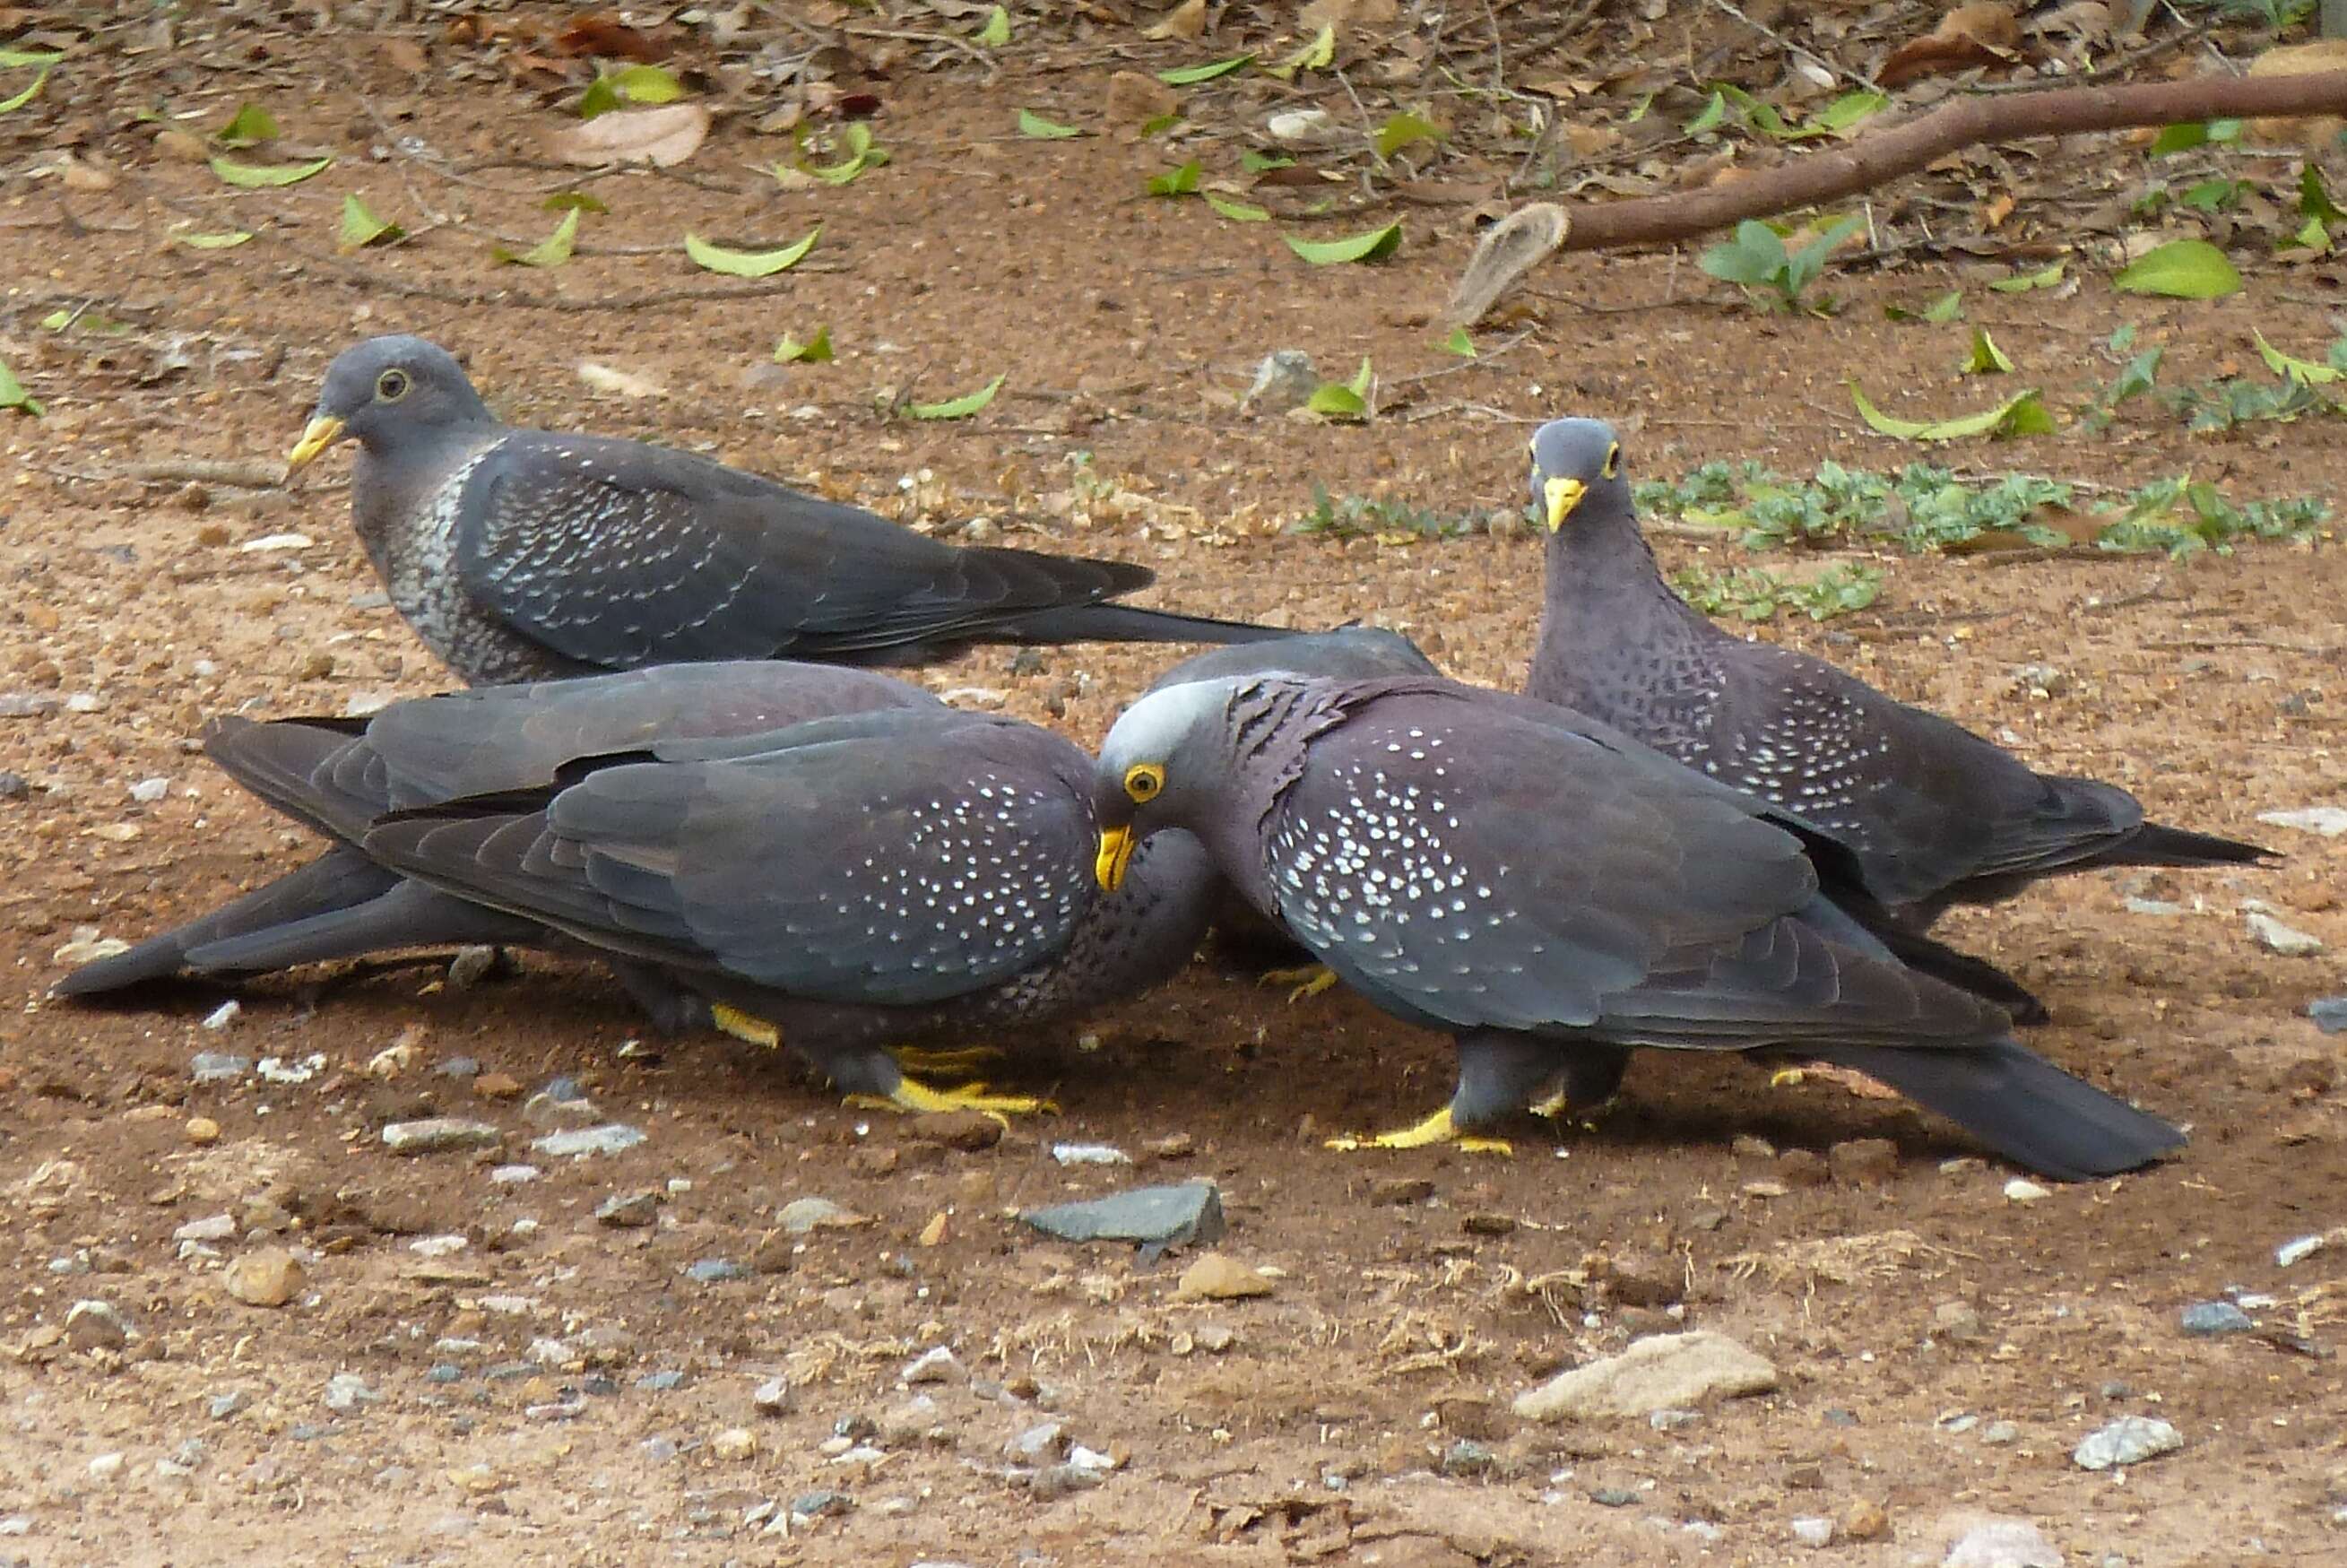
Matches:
[1803,1040,2185,1181]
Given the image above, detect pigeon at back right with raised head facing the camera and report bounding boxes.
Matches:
[1526,420,2272,930]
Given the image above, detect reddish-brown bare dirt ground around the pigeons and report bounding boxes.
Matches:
[0,4,2347,1568]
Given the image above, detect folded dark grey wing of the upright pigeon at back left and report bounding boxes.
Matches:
[455,432,1152,669]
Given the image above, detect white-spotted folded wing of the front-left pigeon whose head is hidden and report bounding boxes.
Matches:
[366,714,1096,1002]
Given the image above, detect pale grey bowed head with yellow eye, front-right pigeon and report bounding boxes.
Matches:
[1091,676,1249,892]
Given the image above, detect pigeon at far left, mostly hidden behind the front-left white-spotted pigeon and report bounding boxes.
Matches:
[56,662,943,1030]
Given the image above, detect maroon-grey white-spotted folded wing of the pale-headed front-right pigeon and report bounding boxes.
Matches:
[1268,695,1816,1028]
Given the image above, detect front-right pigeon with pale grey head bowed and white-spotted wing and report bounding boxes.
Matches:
[1094,676,2183,1178]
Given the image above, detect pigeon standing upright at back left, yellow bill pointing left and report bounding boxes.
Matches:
[286,335,1279,686]
